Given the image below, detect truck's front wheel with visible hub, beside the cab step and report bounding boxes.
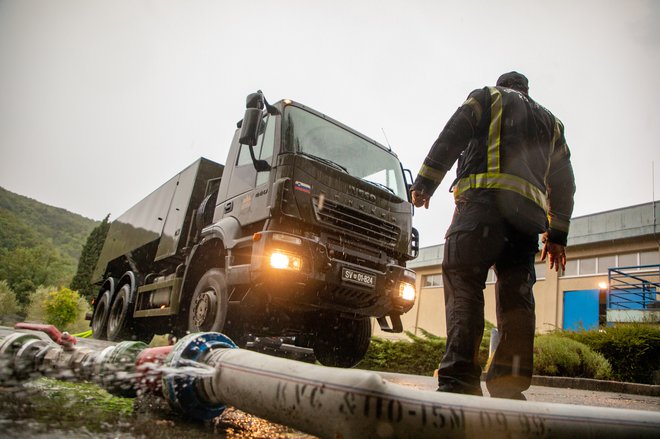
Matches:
[188,268,228,332]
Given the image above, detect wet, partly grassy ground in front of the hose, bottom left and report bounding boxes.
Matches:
[0,379,313,439]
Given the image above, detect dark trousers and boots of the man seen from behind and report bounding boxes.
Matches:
[438,202,538,397]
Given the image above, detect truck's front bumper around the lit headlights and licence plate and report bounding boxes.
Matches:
[250,232,415,317]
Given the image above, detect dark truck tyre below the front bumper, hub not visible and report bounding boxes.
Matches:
[314,317,371,367]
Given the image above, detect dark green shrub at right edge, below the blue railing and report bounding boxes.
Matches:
[561,323,660,384]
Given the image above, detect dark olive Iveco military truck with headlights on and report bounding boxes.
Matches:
[91,91,419,367]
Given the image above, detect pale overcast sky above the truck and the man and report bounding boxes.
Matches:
[0,0,660,246]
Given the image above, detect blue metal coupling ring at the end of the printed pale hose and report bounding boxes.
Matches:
[163,332,238,421]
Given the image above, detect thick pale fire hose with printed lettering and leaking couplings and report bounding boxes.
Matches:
[0,324,660,438]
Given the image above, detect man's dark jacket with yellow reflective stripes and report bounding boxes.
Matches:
[413,87,575,245]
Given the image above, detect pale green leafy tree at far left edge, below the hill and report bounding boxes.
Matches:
[0,242,73,307]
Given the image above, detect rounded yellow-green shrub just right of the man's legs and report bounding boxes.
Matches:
[534,334,612,380]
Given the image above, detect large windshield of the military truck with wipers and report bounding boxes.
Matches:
[284,106,408,200]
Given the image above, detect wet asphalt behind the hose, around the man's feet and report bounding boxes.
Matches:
[379,372,660,412]
